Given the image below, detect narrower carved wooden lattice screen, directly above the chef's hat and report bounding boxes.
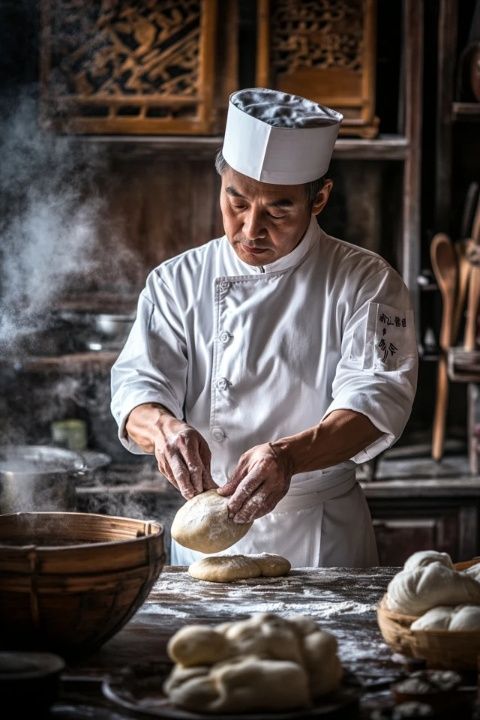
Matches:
[257,0,378,138]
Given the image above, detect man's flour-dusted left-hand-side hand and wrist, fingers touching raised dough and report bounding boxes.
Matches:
[126,403,217,500]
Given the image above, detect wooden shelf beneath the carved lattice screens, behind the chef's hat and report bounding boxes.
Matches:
[76,135,409,160]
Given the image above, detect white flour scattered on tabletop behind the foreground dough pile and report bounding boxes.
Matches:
[147,566,398,672]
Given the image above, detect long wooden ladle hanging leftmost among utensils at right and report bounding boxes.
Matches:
[430,233,458,460]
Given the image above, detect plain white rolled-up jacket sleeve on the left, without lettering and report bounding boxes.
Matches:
[111,269,187,454]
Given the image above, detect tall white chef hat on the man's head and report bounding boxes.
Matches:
[222,88,343,185]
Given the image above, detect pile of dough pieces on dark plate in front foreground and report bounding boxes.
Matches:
[164,613,342,713]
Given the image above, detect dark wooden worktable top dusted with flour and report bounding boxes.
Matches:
[45,566,472,720]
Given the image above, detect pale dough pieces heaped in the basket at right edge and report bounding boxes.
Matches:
[386,550,480,630]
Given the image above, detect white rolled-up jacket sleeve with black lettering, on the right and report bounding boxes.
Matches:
[324,268,418,463]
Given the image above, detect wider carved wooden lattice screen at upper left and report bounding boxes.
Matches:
[41,0,232,134]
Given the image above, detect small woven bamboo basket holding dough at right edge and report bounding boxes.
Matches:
[377,557,480,670]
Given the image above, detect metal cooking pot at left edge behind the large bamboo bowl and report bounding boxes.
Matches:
[0,445,93,513]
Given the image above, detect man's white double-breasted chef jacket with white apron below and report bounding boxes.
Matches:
[111,216,418,567]
